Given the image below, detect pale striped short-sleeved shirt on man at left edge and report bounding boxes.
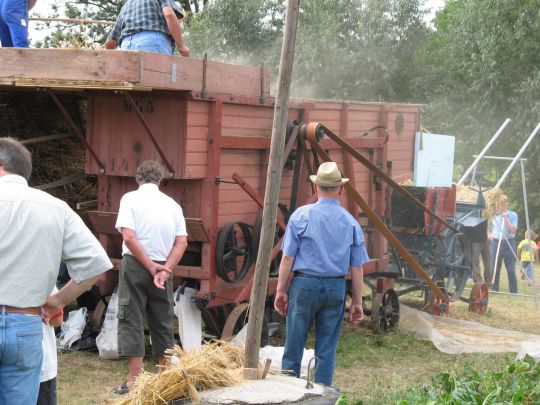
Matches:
[0,175,112,308]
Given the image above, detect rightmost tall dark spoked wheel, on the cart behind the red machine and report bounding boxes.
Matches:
[445,233,470,302]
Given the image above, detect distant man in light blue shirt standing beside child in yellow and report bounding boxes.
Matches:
[488,195,518,293]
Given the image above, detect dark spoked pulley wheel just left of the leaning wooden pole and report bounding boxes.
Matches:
[216,222,252,283]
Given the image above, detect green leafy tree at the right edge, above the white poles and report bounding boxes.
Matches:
[422,0,540,229]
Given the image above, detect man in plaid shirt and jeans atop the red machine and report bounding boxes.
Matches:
[105,0,189,56]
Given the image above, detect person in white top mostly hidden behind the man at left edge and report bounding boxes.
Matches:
[36,287,64,405]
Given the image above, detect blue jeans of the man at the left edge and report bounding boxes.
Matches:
[0,313,43,405]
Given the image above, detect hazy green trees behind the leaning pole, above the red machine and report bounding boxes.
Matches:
[187,0,428,101]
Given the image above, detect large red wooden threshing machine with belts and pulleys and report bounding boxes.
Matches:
[0,49,430,336]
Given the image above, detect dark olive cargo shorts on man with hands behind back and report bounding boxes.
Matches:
[118,254,174,359]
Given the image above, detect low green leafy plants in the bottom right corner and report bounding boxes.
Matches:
[397,356,540,405]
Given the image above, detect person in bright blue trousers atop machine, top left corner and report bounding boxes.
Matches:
[0,0,36,48]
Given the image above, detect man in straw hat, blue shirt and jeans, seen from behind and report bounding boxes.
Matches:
[274,162,369,386]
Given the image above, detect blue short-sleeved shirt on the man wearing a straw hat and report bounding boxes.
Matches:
[282,198,369,277]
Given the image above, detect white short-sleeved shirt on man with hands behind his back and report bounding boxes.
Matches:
[116,183,187,261]
